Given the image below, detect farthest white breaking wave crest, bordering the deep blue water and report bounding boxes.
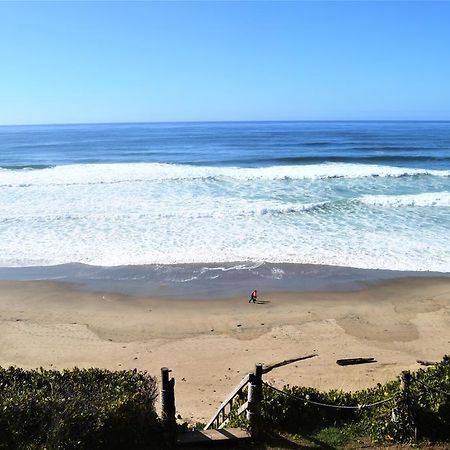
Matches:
[0,163,450,187]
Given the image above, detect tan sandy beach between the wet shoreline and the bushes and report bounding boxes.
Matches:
[0,278,450,422]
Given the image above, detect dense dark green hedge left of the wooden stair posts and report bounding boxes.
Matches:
[0,367,162,449]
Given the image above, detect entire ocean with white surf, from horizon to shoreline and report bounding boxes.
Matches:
[0,122,450,298]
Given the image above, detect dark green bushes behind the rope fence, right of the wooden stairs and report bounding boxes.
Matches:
[232,356,450,442]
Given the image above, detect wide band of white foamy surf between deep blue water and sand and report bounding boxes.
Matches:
[0,164,450,277]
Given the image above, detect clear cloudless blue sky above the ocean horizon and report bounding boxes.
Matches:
[0,1,450,124]
